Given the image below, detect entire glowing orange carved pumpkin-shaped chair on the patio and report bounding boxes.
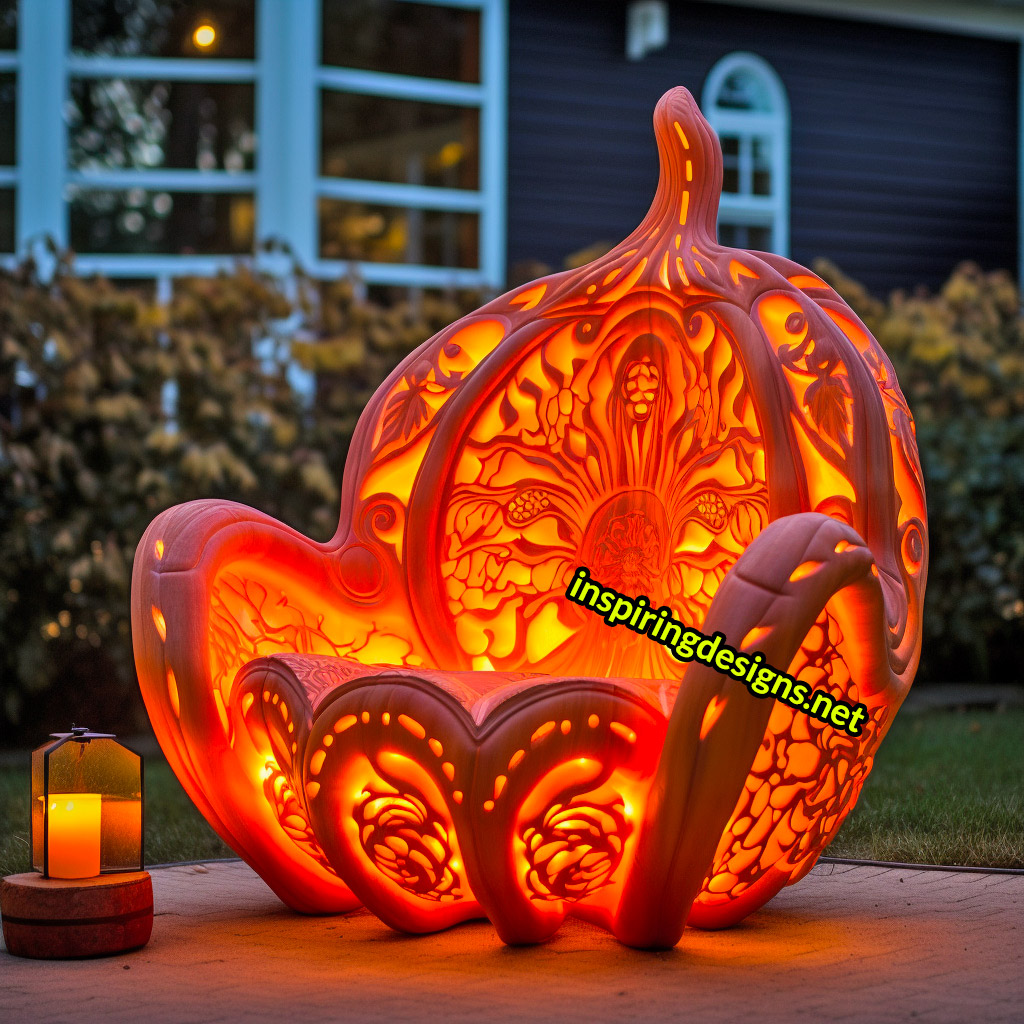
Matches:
[132,89,928,947]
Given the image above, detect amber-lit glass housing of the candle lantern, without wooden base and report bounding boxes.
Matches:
[32,736,143,874]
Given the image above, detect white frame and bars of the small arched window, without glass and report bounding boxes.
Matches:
[701,50,790,256]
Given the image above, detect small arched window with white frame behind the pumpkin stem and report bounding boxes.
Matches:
[701,52,790,256]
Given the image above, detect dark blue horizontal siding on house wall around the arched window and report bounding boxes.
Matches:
[508,0,1018,293]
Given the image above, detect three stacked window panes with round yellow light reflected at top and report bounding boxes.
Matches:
[65,0,257,258]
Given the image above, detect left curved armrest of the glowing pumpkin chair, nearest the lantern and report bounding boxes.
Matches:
[132,501,359,912]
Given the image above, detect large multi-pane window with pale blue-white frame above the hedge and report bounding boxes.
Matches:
[0,0,505,285]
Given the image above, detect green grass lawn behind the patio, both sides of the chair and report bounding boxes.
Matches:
[0,711,1024,874]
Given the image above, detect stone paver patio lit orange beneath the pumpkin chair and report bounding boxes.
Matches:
[0,862,1024,1024]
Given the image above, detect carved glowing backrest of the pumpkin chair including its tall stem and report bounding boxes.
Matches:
[336,88,927,696]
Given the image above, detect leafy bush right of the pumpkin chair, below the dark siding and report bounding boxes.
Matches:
[815,262,1024,682]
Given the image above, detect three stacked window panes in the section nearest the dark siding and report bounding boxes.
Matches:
[317,0,482,269]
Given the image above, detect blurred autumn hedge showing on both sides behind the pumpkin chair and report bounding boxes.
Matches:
[0,256,1024,745]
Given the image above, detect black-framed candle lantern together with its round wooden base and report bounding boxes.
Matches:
[0,727,153,958]
